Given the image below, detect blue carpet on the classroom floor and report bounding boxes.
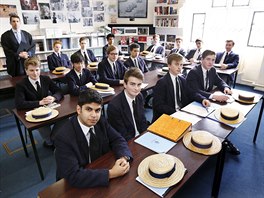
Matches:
[0,86,264,198]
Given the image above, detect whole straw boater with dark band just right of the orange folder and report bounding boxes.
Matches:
[183,131,222,155]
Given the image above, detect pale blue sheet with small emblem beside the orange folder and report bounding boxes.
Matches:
[135,132,176,153]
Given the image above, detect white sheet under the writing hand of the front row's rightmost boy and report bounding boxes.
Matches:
[181,101,215,118]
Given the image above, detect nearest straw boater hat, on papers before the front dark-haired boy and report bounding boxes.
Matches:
[138,153,186,188]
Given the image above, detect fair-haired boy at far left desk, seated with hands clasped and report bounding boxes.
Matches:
[15,56,63,148]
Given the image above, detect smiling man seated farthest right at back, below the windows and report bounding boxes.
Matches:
[215,40,239,85]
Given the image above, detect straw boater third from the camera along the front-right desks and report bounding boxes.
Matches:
[214,107,244,124]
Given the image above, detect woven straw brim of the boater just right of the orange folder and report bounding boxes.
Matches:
[182,131,222,155]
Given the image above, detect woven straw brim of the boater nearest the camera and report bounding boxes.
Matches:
[138,154,186,188]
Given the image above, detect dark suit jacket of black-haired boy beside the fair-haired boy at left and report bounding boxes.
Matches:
[66,69,97,96]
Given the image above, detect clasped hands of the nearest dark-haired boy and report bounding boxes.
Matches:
[109,158,130,179]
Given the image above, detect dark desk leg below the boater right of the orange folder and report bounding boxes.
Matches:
[211,141,227,198]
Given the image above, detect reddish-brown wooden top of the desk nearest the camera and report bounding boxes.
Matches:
[38,119,227,198]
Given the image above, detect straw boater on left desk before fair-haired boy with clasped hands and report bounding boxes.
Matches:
[26,107,59,122]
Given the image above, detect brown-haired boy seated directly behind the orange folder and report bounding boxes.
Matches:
[107,67,148,141]
